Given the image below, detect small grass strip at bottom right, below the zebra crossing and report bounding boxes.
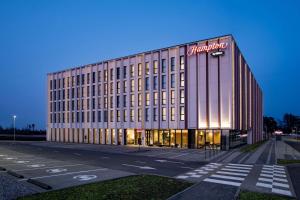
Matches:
[239,190,292,200]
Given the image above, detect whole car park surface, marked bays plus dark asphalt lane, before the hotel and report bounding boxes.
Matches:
[0,142,204,199]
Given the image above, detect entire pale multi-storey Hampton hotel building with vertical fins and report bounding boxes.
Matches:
[47,35,263,150]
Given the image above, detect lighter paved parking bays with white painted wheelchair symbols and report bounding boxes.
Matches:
[0,148,133,189]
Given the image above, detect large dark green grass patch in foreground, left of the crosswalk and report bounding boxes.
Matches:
[18,175,192,200]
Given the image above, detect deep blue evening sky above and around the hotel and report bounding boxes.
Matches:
[0,0,300,129]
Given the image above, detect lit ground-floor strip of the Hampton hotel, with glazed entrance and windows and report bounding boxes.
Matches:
[47,128,247,150]
